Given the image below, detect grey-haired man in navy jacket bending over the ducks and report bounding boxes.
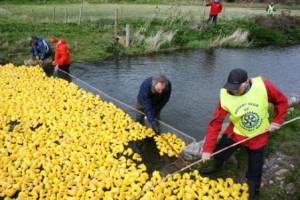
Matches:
[136,75,172,133]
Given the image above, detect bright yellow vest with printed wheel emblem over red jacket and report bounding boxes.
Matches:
[220,77,270,137]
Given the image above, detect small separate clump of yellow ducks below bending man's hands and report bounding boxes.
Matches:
[154,133,185,157]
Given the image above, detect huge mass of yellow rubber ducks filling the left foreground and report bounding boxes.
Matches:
[0,64,248,200]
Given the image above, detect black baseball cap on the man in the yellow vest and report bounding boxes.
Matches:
[224,68,248,91]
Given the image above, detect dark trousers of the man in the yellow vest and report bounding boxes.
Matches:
[214,135,264,184]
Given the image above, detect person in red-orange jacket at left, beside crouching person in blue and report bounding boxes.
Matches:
[50,37,71,73]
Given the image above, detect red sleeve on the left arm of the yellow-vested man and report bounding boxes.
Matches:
[203,102,228,153]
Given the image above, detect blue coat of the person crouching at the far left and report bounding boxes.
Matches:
[31,37,52,60]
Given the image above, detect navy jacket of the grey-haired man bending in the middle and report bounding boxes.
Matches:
[137,77,172,123]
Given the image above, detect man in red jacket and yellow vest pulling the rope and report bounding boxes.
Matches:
[200,69,288,200]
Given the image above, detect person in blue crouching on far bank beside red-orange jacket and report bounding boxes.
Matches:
[24,36,53,67]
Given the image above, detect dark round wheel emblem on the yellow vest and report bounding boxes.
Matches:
[240,112,262,131]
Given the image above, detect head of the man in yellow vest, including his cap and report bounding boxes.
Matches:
[224,68,249,96]
